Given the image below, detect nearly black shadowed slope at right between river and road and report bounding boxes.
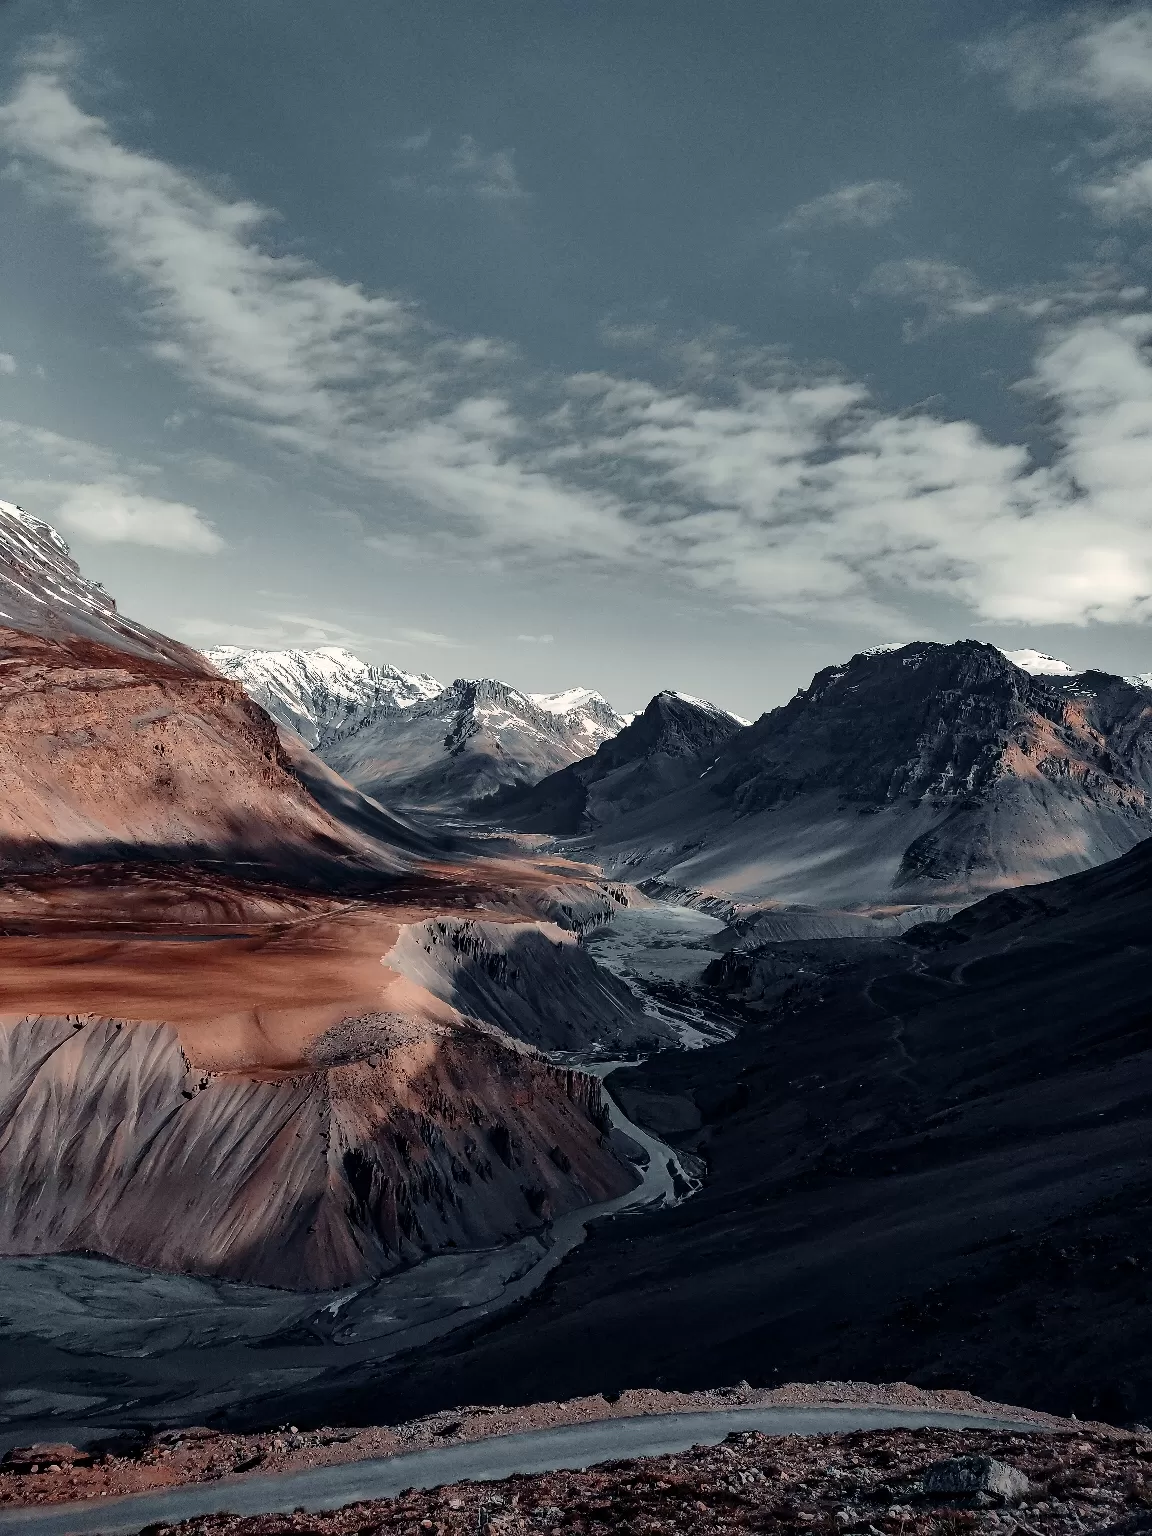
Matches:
[287,843,1152,1419]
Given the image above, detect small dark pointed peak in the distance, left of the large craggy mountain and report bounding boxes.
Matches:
[484,691,746,836]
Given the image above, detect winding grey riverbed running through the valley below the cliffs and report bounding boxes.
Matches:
[0,905,728,1452]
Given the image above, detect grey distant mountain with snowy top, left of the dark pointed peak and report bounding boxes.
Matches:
[321,677,625,809]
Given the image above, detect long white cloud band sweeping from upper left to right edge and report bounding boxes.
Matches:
[0,66,1152,633]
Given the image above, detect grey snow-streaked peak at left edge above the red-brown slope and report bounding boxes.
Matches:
[0,501,209,673]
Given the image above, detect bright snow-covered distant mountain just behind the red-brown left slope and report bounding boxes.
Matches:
[204,645,444,746]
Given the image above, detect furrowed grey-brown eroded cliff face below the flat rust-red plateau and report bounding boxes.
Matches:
[0,1015,634,1290]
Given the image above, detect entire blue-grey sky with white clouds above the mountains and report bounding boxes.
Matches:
[0,0,1152,717]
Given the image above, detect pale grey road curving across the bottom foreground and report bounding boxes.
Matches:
[0,1405,1040,1536]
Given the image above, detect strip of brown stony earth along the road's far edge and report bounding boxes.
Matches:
[0,1381,1105,1511]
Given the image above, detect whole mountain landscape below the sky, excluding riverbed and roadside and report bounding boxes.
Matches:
[11,502,1152,1418]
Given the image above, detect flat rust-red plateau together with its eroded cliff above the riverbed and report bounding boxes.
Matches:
[0,862,651,1290]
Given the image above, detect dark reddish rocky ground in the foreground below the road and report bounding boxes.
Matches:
[72,1430,1152,1536]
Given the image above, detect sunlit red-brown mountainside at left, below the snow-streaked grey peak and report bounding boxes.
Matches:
[0,628,407,880]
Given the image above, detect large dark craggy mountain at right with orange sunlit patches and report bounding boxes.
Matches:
[552,641,1152,909]
